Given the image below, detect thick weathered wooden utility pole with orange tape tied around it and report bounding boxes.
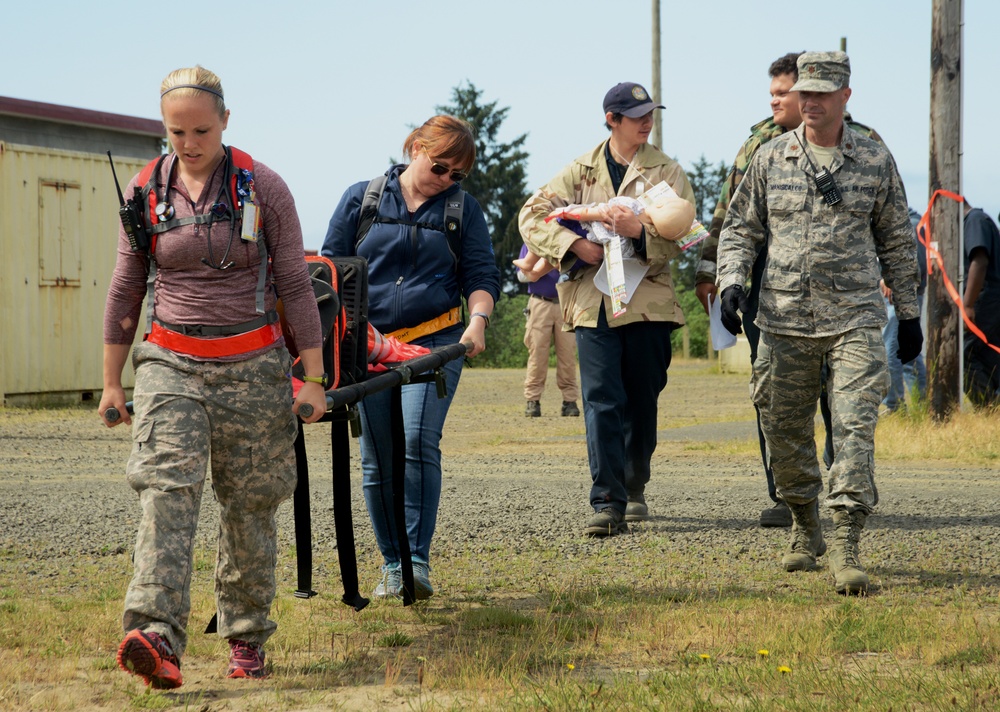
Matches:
[926,0,963,420]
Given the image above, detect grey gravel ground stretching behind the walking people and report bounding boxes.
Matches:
[0,362,1000,595]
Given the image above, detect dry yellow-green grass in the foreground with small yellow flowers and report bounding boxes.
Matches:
[0,537,1000,710]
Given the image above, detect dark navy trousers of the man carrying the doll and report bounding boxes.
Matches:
[576,304,673,514]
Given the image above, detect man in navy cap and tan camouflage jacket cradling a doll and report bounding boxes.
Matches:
[519,82,694,536]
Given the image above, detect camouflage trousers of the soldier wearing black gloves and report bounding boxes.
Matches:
[750,328,889,513]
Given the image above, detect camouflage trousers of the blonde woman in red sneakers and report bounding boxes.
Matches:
[122,343,297,655]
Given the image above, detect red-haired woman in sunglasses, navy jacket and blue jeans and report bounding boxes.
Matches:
[322,115,500,599]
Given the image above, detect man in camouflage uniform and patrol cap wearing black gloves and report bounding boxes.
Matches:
[719,52,922,593]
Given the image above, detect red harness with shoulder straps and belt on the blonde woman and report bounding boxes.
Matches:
[138,146,282,359]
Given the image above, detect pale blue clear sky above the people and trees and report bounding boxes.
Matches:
[0,0,1000,253]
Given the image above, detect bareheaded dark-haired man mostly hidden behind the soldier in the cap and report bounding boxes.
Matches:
[695,52,884,527]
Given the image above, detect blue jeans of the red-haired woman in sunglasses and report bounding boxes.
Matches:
[359,328,463,564]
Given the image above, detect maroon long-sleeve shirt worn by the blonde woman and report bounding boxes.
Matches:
[104,151,322,361]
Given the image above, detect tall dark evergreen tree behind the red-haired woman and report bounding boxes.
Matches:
[435,82,529,293]
